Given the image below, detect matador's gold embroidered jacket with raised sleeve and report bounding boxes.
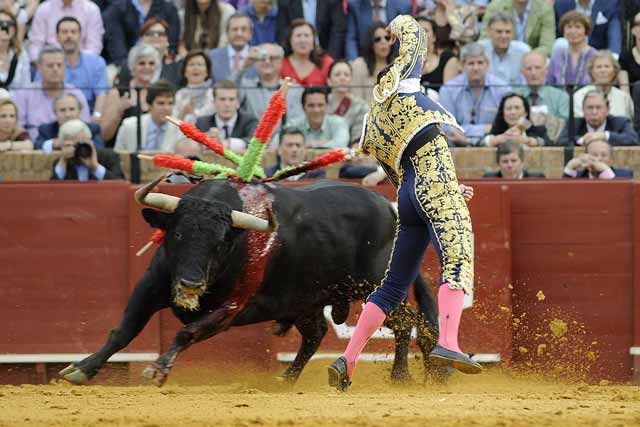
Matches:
[360,15,462,181]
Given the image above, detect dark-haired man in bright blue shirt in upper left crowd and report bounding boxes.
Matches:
[56,16,109,116]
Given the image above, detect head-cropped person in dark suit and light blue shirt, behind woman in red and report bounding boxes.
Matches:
[276,0,347,59]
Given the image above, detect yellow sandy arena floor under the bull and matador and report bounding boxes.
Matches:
[0,361,640,427]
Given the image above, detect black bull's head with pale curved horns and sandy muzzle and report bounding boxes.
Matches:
[135,176,277,310]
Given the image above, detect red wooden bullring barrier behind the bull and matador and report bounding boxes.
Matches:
[0,181,640,382]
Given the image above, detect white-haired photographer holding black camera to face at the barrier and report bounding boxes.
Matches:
[51,120,124,181]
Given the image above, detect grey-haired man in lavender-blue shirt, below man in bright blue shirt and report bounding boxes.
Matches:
[13,46,91,141]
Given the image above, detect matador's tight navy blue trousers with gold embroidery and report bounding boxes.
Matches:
[368,125,473,314]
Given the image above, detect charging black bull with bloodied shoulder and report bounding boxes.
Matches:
[60,180,438,385]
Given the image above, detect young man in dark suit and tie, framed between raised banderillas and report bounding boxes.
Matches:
[196,80,258,153]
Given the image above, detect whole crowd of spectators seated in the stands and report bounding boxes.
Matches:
[0,0,640,184]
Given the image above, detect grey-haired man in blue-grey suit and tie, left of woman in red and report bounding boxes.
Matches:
[209,13,256,82]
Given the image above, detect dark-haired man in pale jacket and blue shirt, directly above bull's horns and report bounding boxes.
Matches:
[114,80,181,153]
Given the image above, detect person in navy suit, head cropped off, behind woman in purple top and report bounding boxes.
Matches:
[553,0,622,55]
